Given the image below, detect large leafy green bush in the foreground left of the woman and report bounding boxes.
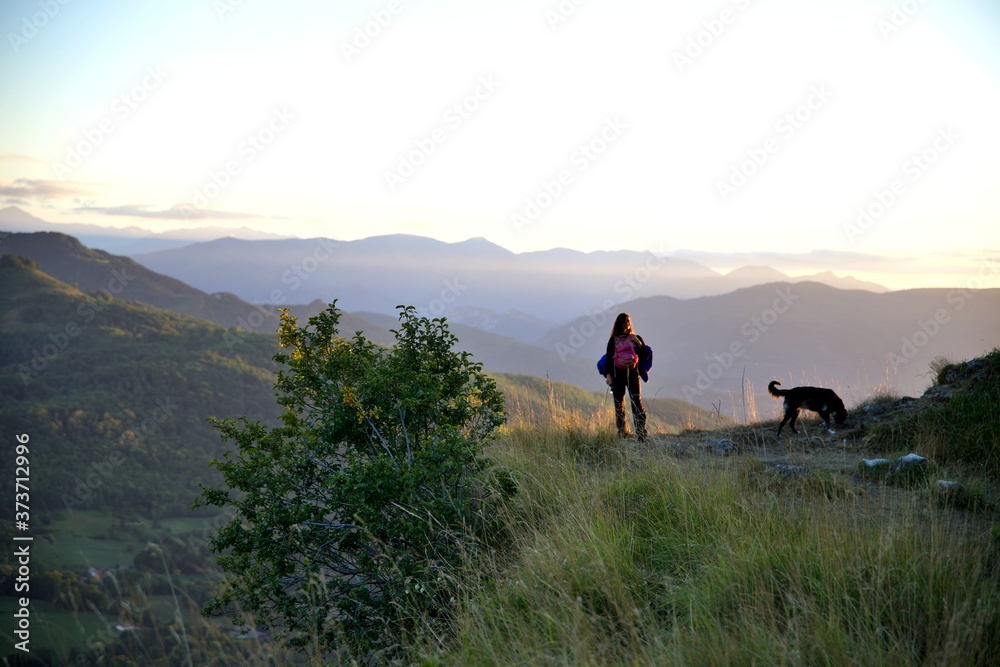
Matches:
[198,304,504,660]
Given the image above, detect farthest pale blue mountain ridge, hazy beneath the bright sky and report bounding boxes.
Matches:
[133,235,885,334]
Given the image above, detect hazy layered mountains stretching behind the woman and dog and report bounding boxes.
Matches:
[0,217,1000,416]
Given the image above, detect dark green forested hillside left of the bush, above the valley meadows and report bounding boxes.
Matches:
[0,255,277,518]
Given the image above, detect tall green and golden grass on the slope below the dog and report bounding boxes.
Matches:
[417,428,1000,665]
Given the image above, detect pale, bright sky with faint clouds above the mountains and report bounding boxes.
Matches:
[0,0,1000,288]
